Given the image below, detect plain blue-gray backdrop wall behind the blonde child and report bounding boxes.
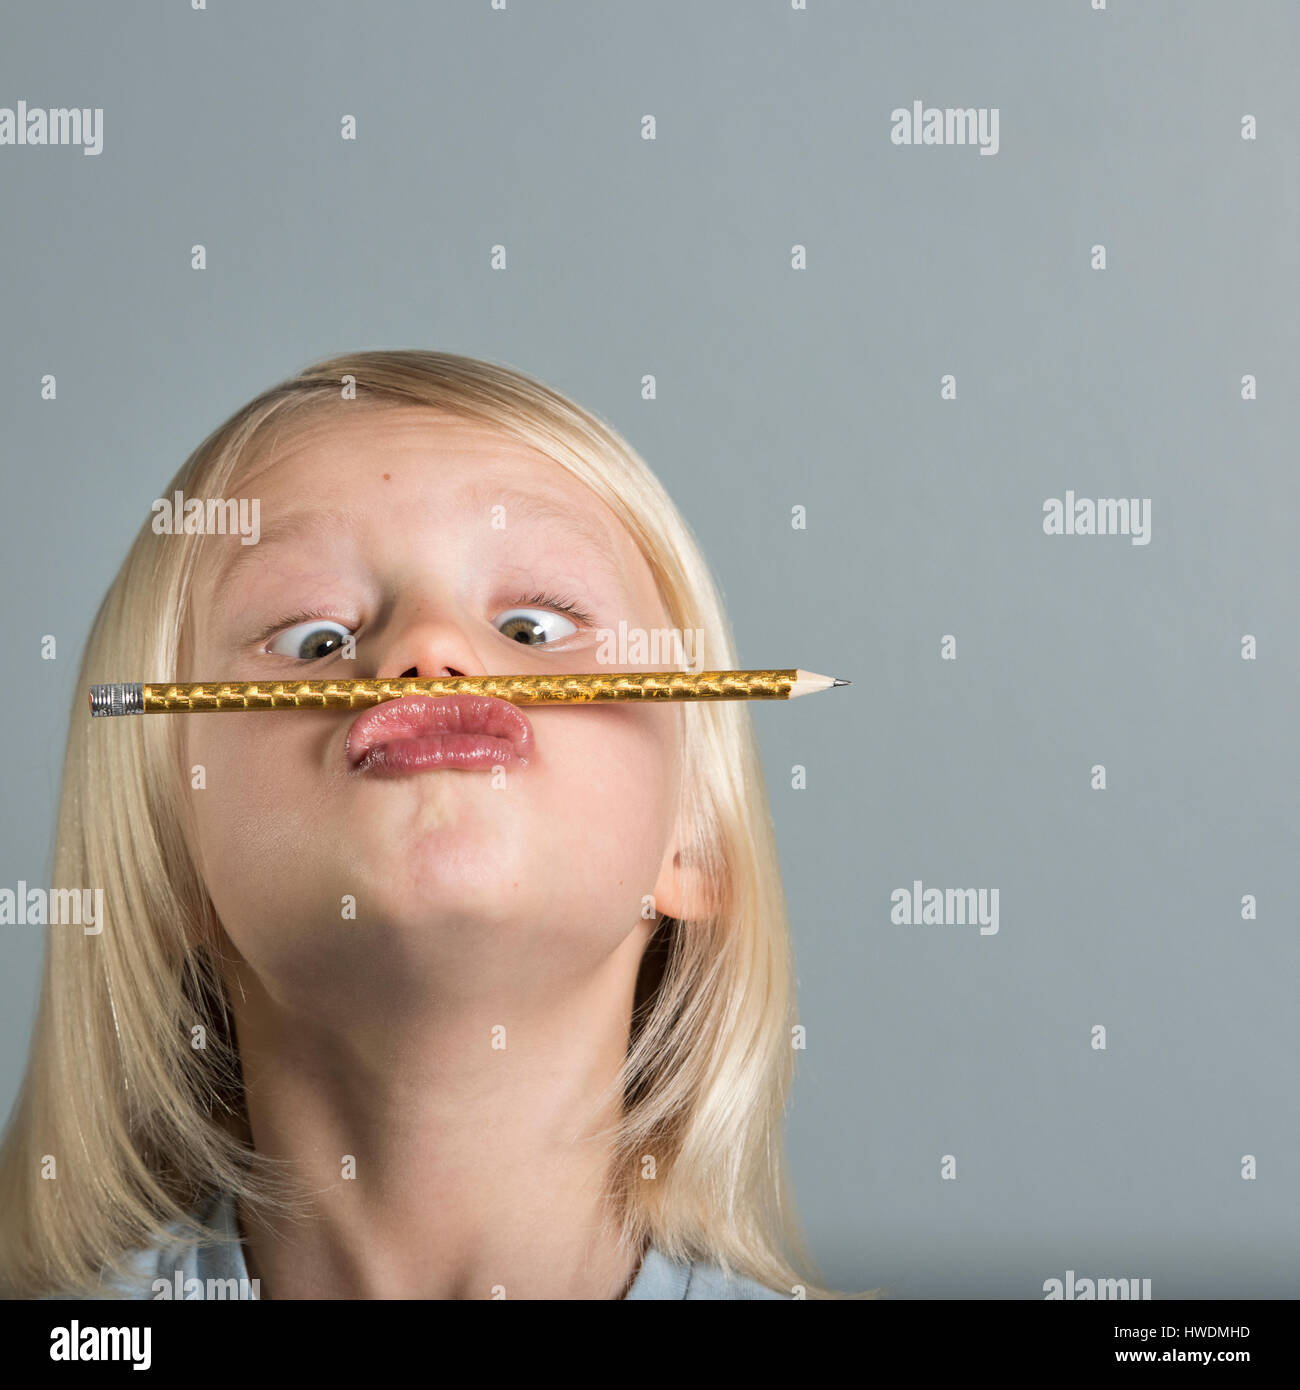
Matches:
[0,0,1300,1298]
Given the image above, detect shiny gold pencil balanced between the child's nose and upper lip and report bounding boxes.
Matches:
[90,670,851,716]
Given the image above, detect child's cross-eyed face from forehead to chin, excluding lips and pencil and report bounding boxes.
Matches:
[184,407,695,1022]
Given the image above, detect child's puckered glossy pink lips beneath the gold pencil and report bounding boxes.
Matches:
[346,695,533,777]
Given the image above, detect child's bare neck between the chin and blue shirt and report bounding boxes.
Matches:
[229,952,641,1300]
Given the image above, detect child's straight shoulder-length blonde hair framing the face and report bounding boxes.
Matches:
[0,350,873,1298]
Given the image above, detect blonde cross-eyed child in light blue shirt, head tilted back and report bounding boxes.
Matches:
[0,352,862,1298]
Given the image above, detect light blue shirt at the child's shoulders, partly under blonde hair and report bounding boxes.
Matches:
[54,1194,793,1300]
